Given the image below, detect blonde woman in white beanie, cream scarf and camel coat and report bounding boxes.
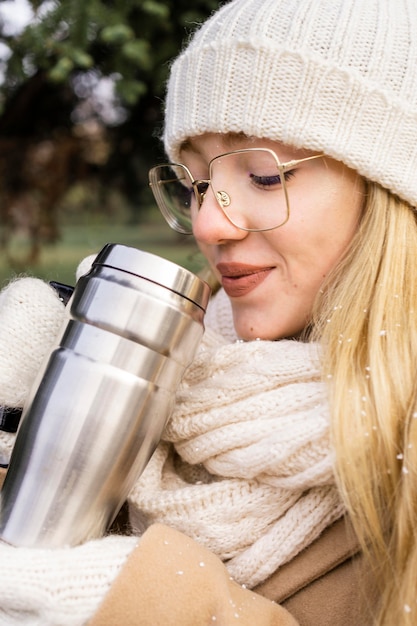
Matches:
[0,0,417,626]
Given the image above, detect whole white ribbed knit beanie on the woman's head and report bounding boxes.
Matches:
[164,0,417,206]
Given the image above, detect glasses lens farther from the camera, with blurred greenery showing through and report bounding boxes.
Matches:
[149,164,194,234]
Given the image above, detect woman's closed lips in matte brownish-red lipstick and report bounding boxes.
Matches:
[217,263,273,298]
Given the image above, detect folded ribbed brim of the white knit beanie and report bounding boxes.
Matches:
[164,41,417,206]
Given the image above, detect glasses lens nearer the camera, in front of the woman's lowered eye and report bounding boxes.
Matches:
[210,148,289,230]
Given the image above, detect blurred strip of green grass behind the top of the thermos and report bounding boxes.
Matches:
[0,210,204,287]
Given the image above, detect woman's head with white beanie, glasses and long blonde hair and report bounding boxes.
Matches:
[143,0,417,624]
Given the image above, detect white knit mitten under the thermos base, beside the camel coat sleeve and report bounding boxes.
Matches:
[0,536,138,626]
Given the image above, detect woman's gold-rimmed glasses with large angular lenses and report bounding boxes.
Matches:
[149,148,324,235]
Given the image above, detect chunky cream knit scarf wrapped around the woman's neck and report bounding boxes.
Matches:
[129,290,344,588]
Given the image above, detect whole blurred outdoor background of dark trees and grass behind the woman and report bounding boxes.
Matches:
[0,0,221,287]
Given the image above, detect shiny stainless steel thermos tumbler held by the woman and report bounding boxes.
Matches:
[0,244,210,547]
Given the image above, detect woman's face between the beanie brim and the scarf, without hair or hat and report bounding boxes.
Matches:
[181,134,363,340]
